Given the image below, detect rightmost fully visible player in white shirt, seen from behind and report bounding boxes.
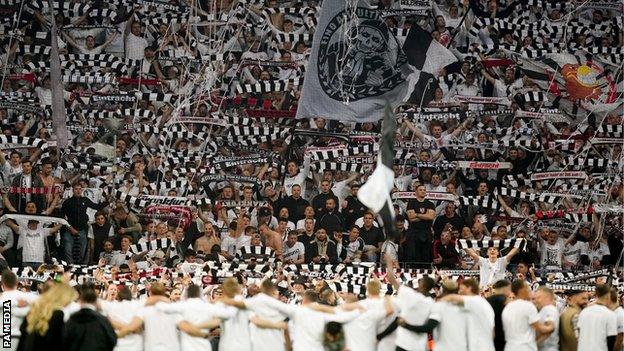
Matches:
[578,284,617,351]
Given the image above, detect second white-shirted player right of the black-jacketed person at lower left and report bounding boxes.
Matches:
[117,282,182,351]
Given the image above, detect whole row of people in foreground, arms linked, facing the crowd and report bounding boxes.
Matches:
[0,254,624,351]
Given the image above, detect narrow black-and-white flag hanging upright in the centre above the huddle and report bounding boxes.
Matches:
[358,104,397,241]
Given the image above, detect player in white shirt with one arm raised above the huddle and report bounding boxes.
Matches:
[386,257,435,351]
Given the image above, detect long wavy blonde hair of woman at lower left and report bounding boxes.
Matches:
[26,283,78,336]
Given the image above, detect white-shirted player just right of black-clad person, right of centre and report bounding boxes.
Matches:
[502,280,554,351]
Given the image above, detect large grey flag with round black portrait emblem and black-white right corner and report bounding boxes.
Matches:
[297,0,455,122]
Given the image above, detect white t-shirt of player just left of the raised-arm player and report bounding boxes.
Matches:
[343,302,386,351]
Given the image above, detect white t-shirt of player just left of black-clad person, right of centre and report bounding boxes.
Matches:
[464,296,494,351]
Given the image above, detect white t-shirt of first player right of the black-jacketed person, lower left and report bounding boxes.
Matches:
[100,300,144,351]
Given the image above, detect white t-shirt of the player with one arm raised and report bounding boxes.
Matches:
[396,286,433,351]
